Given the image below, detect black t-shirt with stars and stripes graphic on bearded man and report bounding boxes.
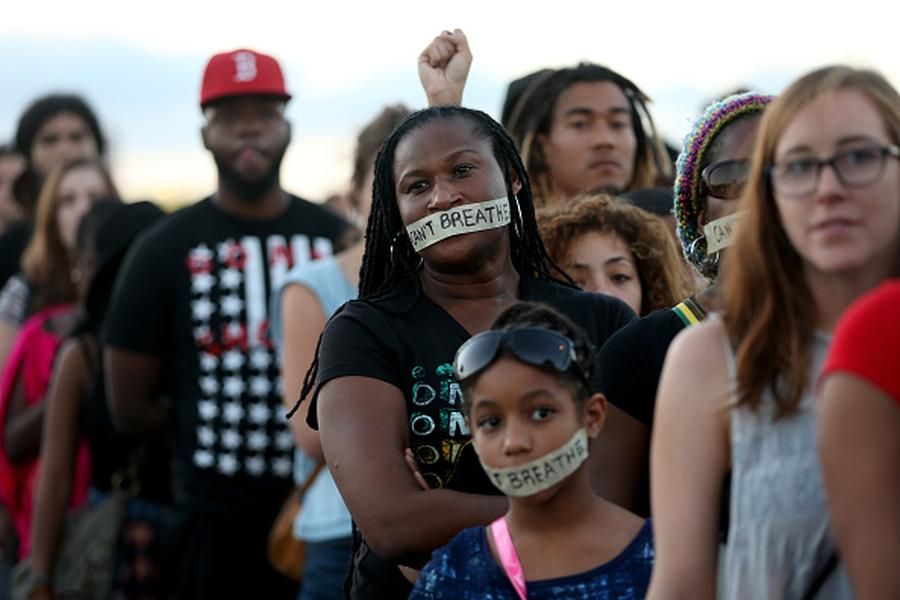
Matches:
[104,197,348,514]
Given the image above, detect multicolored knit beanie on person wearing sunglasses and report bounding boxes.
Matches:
[674,92,774,281]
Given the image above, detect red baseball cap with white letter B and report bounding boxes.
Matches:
[200,48,291,106]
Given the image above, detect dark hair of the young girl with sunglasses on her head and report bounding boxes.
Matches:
[460,302,595,411]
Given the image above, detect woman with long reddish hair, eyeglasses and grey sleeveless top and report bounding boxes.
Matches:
[650,67,900,600]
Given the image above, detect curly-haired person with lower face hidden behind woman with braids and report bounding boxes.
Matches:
[538,194,691,315]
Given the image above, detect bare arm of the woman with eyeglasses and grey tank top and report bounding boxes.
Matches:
[647,320,731,600]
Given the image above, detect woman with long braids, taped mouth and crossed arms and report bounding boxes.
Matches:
[301,106,634,598]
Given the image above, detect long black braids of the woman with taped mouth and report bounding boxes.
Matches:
[296,106,575,418]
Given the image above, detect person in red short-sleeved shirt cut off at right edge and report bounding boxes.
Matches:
[818,279,900,600]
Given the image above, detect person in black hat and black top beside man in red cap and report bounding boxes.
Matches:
[29,202,170,598]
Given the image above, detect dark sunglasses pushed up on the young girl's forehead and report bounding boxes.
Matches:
[453,327,589,387]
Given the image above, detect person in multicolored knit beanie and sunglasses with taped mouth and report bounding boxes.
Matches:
[600,92,772,515]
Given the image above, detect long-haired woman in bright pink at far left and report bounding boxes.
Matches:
[0,159,117,556]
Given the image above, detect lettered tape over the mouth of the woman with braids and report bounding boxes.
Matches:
[406,196,511,252]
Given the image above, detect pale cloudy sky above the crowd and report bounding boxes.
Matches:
[0,0,900,202]
